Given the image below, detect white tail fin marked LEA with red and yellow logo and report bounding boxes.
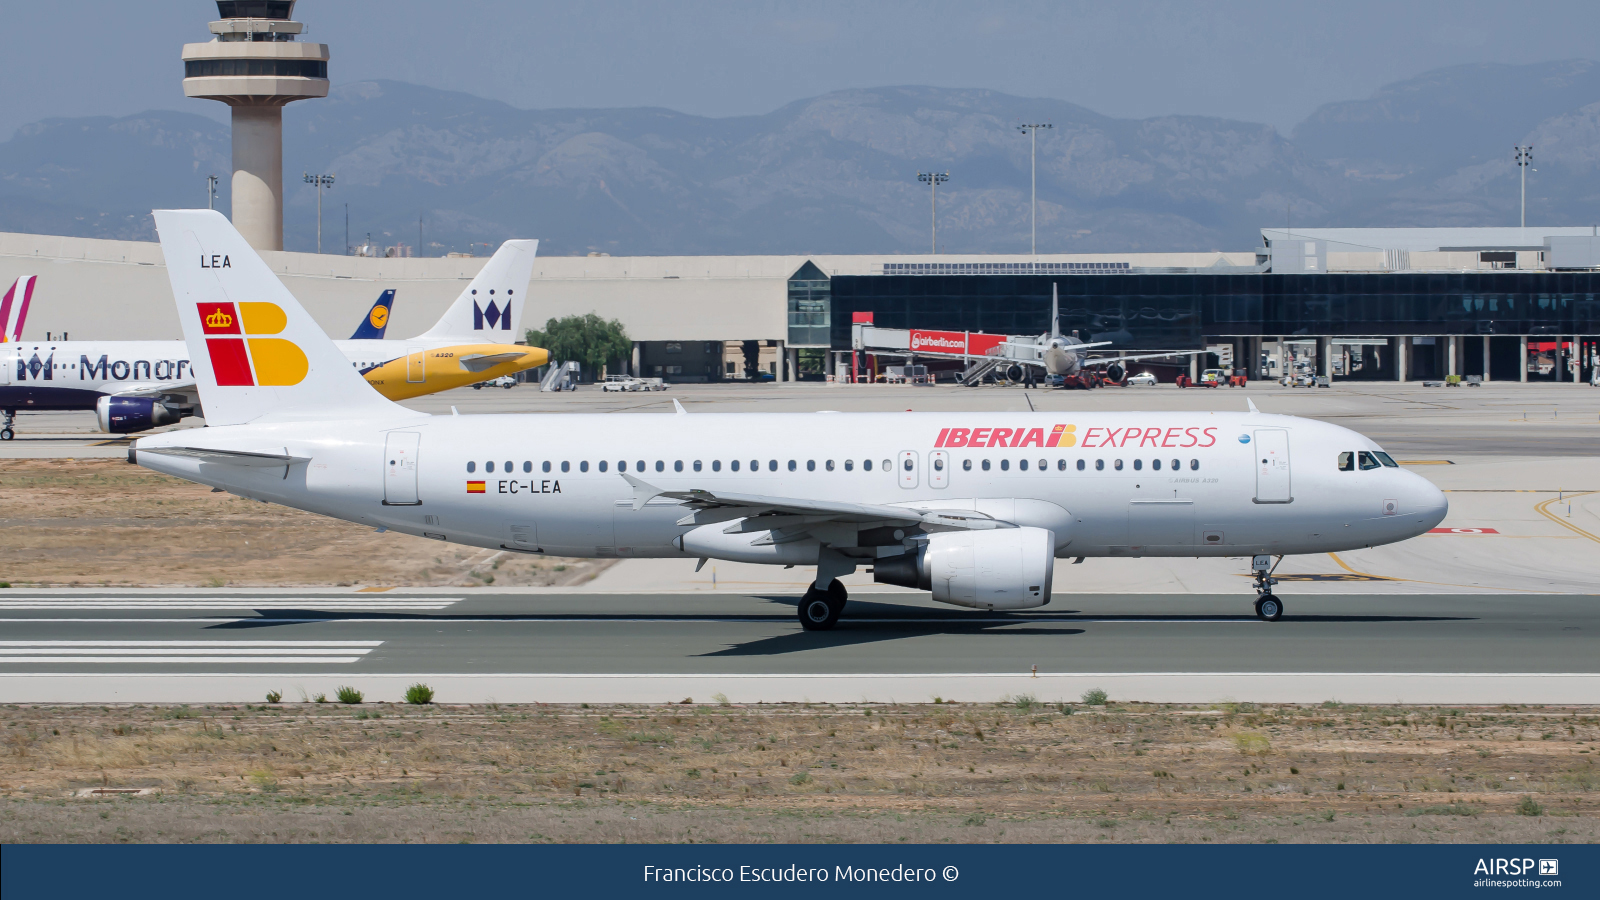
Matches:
[155,210,410,424]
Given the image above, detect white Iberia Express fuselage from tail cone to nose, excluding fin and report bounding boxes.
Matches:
[136,412,1446,564]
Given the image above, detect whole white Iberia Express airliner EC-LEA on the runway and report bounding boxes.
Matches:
[128,210,1446,629]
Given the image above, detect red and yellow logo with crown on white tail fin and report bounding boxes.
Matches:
[197,303,310,388]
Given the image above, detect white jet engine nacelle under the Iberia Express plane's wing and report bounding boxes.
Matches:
[872,528,1056,610]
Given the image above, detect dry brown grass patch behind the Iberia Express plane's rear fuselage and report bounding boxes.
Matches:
[0,460,611,588]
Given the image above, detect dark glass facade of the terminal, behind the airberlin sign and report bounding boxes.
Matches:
[825,271,1600,351]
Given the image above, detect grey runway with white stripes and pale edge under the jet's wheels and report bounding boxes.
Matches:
[0,591,1600,703]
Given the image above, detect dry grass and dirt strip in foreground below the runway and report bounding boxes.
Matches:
[0,697,1600,844]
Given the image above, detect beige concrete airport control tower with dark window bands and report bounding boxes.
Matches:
[184,0,328,250]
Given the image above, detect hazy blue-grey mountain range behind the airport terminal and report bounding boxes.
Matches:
[0,59,1600,256]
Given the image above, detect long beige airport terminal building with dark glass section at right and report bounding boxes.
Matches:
[0,226,1600,381]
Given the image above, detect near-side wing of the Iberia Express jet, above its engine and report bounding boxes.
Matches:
[622,472,1014,533]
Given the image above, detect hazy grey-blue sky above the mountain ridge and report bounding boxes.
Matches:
[0,0,1600,139]
